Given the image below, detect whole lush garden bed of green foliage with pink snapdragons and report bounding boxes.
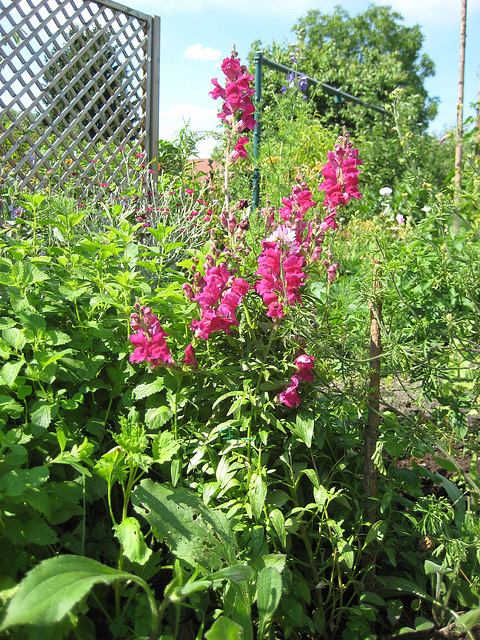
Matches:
[0,42,480,640]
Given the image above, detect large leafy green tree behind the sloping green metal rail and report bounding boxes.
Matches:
[250,5,447,188]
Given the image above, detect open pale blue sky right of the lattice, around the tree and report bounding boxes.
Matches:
[123,0,480,157]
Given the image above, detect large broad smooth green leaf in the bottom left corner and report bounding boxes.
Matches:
[0,556,137,630]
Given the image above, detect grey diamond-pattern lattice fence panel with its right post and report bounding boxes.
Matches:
[0,0,160,188]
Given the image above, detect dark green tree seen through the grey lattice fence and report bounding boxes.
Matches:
[43,26,136,140]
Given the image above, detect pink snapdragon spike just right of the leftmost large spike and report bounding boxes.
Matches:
[190,256,250,340]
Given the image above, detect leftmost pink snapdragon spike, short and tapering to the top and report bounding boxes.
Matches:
[129,303,174,369]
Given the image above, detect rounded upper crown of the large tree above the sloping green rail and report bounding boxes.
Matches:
[294,5,437,131]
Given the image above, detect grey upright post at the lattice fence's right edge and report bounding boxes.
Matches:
[145,16,160,176]
